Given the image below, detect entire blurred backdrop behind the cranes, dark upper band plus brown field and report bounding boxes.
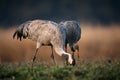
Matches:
[0,0,120,63]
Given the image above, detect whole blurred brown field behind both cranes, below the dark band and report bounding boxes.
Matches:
[0,24,120,63]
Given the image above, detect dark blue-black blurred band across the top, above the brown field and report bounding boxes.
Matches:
[0,0,120,27]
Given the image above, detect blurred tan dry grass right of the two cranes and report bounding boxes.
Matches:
[79,25,120,60]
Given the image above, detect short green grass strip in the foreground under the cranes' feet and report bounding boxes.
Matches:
[0,61,120,80]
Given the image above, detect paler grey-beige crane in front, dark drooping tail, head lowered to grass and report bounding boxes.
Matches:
[13,20,75,65]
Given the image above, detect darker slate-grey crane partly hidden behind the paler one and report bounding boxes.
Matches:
[59,21,81,57]
